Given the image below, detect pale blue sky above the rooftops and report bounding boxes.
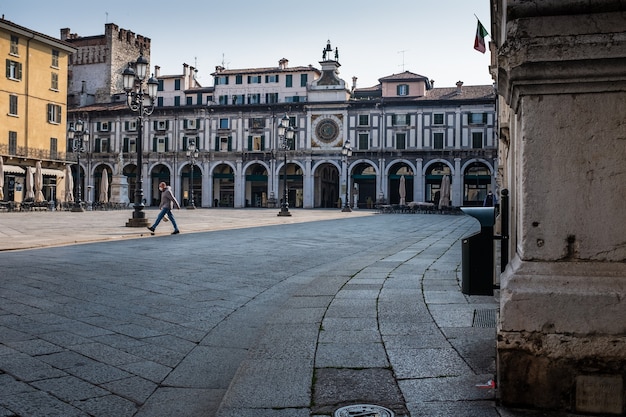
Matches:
[0,0,493,87]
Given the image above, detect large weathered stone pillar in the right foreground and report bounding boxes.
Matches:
[491,0,626,415]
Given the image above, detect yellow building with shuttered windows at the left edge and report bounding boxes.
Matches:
[0,19,76,206]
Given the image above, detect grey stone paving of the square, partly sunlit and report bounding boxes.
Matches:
[0,209,580,417]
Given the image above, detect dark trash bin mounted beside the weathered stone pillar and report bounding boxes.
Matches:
[461,207,496,295]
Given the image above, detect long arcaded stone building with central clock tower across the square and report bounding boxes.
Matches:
[63,33,497,208]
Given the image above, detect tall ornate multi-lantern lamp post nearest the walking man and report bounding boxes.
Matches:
[122,51,159,227]
